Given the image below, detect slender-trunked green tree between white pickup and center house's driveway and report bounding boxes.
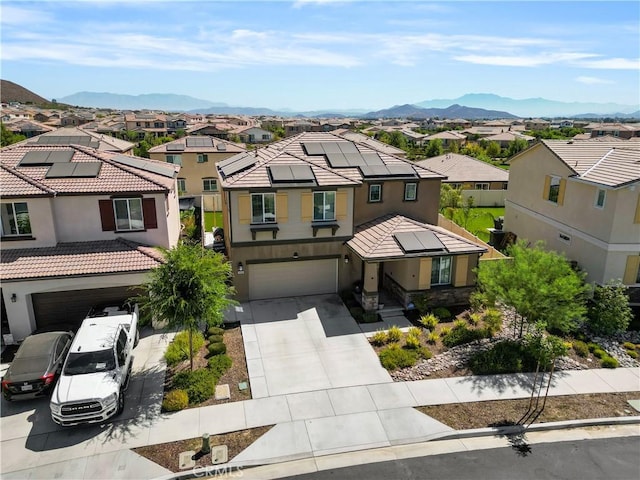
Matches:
[134,244,234,370]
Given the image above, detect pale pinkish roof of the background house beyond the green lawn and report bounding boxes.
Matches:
[416,153,509,183]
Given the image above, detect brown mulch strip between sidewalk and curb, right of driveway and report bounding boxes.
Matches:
[417,392,640,430]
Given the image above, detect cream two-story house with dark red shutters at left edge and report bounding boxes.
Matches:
[0,144,180,341]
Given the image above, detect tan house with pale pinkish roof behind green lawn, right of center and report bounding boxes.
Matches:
[416,153,509,207]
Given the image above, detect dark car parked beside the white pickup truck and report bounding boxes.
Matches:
[2,332,73,401]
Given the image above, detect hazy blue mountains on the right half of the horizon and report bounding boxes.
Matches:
[416,93,639,118]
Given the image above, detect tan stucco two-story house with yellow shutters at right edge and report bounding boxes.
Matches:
[504,140,640,304]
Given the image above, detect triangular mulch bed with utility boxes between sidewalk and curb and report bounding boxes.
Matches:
[132,425,273,472]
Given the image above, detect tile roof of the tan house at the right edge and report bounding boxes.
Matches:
[542,140,640,187]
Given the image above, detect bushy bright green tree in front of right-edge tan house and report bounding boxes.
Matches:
[476,240,589,337]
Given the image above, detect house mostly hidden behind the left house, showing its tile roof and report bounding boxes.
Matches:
[21,127,135,155]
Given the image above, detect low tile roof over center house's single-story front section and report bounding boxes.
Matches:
[347,214,487,260]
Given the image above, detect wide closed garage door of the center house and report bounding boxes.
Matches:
[248,258,338,300]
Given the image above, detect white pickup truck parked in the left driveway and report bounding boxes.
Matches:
[50,305,139,426]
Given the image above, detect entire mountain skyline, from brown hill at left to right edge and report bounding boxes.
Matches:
[5,80,640,119]
